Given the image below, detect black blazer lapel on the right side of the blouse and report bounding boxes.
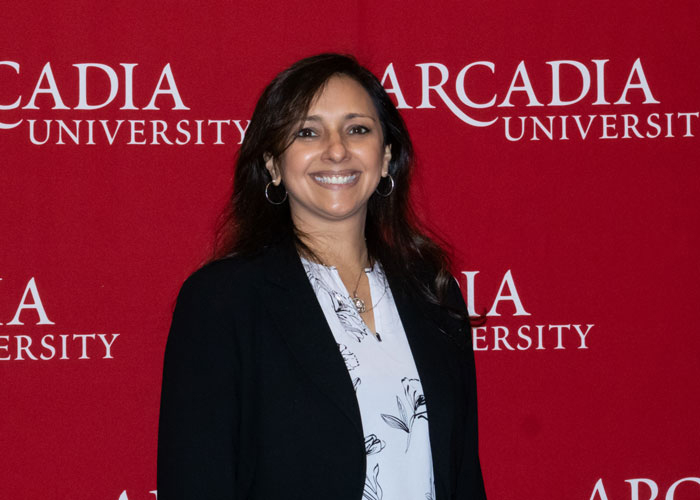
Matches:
[389,279,454,498]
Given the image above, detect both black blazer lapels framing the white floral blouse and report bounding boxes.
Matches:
[263,240,454,497]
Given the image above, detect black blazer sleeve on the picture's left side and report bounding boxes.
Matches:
[157,270,239,500]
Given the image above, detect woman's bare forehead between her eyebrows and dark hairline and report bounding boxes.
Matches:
[307,76,377,118]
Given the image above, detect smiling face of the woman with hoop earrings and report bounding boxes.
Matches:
[266,76,391,230]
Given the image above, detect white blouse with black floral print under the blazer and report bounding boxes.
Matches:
[301,257,435,500]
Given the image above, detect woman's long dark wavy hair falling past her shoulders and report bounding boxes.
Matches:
[212,53,468,330]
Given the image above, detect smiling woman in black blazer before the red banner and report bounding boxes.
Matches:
[158,54,485,500]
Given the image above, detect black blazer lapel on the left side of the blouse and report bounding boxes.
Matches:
[254,241,364,440]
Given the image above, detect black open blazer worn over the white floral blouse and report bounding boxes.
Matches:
[157,238,486,500]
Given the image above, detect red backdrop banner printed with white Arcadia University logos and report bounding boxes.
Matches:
[0,0,700,500]
